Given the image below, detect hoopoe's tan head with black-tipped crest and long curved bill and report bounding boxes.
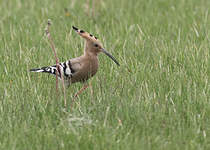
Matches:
[72,26,120,66]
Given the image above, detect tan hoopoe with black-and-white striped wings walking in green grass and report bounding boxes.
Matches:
[30,26,120,92]
